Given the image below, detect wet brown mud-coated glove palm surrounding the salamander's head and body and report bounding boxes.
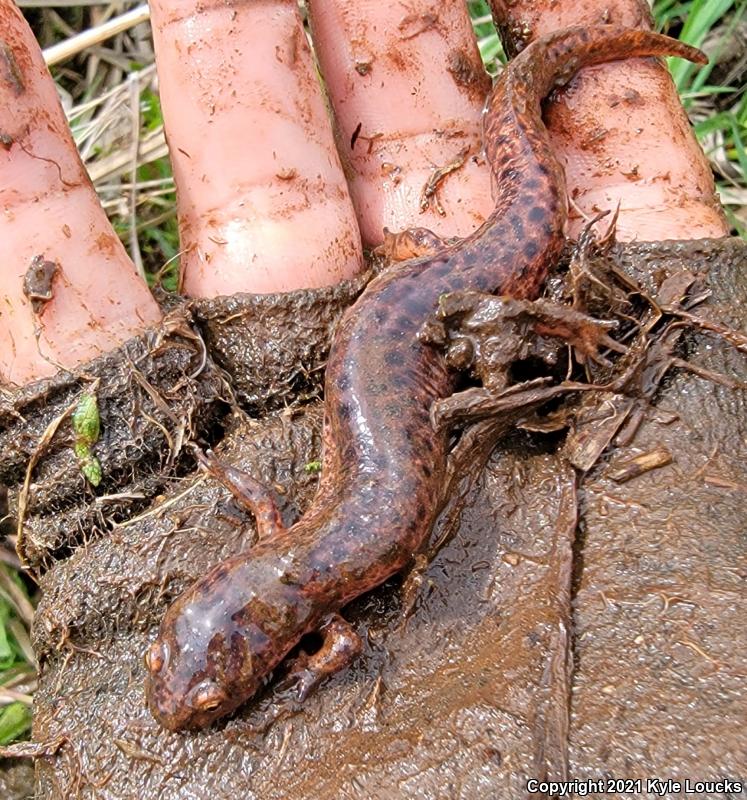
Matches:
[0,240,747,800]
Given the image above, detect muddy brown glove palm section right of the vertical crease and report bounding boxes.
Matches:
[569,241,747,780]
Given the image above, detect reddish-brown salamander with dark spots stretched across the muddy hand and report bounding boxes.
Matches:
[146,26,703,730]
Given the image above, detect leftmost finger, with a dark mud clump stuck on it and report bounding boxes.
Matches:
[0,0,160,384]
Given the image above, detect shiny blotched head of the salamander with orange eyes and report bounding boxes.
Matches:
[145,556,300,731]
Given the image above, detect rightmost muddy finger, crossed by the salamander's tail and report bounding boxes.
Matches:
[491,0,728,241]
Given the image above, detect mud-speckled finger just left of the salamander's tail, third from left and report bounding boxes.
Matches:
[309,0,493,245]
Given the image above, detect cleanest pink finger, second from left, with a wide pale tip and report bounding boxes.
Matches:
[151,0,362,297]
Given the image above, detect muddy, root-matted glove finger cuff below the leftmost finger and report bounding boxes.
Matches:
[0,308,230,571]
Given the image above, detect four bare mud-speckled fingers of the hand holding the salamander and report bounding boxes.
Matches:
[0,0,727,385]
